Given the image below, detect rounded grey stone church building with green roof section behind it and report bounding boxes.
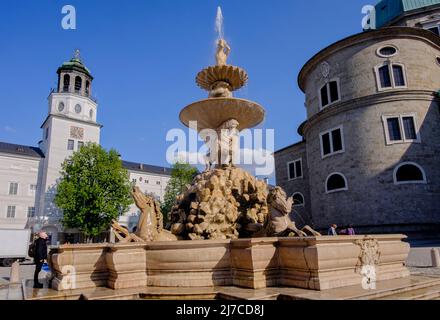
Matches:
[275,0,440,234]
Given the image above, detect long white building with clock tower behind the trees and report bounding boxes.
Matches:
[0,52,171,244]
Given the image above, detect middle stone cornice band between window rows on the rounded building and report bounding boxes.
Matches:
[303,90,440,135]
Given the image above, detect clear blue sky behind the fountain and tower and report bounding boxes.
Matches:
[0,0,376,171]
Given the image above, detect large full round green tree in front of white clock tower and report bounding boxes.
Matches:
[55,143,133,238]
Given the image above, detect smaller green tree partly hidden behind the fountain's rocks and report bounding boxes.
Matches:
[161,162,199,221]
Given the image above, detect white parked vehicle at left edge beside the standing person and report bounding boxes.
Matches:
[0,229,31,267]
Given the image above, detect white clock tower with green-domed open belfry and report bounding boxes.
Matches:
[37,50,102,240]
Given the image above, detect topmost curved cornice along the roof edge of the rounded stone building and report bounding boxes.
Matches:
[298,27,440,92]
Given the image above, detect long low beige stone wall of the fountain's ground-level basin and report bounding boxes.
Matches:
[50,235,409,291]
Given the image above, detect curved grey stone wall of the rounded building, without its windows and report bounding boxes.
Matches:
[275,16,440,232]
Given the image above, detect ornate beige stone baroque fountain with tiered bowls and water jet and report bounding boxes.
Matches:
[37,9,409,297]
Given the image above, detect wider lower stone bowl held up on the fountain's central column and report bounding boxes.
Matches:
[179,98,265,131]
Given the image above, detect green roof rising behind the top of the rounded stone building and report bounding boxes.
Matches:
[376,0,440,28]
